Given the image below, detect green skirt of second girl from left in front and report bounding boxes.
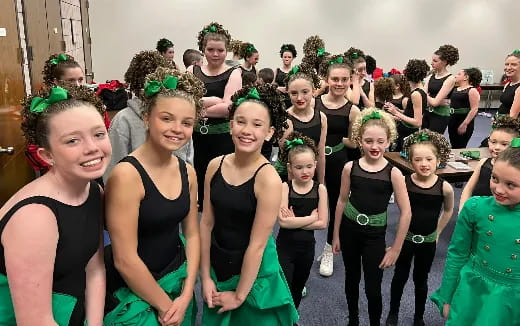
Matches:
[103,262,197,326]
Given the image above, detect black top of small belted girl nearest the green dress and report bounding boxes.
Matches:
[405,175,444,235]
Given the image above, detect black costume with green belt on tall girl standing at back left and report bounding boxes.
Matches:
[192,66,235,210]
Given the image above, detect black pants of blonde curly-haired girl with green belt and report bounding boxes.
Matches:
[340,215,386,326]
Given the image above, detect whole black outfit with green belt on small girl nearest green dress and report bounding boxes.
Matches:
[390,175,444,320]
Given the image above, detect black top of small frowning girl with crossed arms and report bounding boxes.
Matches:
[276,181,320,244]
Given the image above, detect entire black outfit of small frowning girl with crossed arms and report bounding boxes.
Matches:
[276,181,320,308]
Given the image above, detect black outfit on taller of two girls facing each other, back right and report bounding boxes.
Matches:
[422,74,453,135]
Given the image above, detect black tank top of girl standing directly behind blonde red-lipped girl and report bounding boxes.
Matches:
[314,96,352,147]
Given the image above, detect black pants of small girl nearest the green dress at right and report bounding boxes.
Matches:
[390,240,437,319]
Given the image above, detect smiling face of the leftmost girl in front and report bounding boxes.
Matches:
[39,105,112,180]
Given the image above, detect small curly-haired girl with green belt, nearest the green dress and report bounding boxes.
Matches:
[386,129,454,326]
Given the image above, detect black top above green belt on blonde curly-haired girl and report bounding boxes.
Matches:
[349,160,394,215]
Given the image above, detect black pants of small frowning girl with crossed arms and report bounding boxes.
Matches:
[276,241,315,308]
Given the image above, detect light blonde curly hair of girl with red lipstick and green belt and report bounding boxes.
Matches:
[352,108,397,144]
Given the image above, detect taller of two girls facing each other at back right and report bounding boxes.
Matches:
[422,44,459,134]
